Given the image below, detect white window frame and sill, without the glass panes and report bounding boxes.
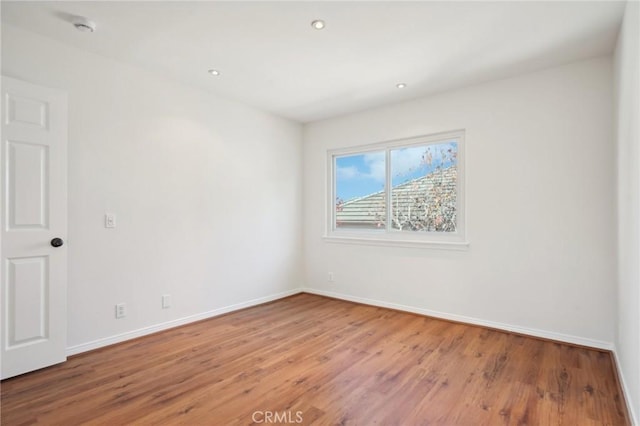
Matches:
[324,130,469,250]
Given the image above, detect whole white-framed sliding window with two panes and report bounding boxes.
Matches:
[327,131,467,248]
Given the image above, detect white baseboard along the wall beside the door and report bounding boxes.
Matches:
[67,288,302,356]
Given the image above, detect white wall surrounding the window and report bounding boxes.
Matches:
[303,57,616,347]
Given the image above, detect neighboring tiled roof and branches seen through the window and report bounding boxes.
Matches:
[336,166,458,230]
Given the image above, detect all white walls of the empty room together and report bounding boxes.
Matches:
[2,10,640,416]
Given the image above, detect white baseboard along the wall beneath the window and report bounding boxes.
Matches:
[302,287,614,351]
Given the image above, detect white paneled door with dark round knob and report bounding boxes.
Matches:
[0,77,67,379]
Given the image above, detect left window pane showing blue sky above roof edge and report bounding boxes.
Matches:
[335,151,386,229]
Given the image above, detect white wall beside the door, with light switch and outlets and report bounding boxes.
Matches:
[2,24,302,349]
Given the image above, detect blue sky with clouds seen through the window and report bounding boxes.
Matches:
[335,141,458,201]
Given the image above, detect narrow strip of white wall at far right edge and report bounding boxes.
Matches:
[615,2,640,424]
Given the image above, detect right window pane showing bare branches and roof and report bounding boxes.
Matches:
[391,141,458,232]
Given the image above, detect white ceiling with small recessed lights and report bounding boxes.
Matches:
[1,1,624,122]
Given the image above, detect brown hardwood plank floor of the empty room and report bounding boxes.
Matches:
[1,294,630,426]
